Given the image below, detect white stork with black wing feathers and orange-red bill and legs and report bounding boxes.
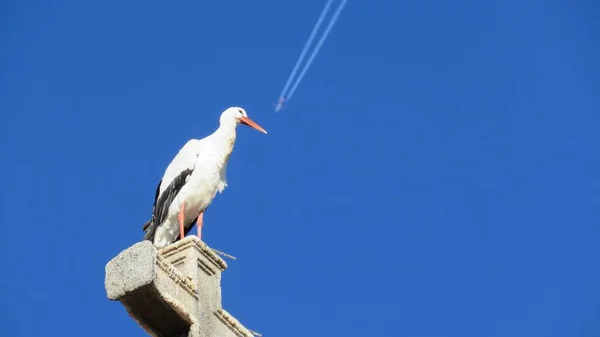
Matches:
[143,107,267,248]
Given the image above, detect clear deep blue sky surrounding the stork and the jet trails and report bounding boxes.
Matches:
[0,0,600,337]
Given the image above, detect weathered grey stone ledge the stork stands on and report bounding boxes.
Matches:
[105,236,252,337]
